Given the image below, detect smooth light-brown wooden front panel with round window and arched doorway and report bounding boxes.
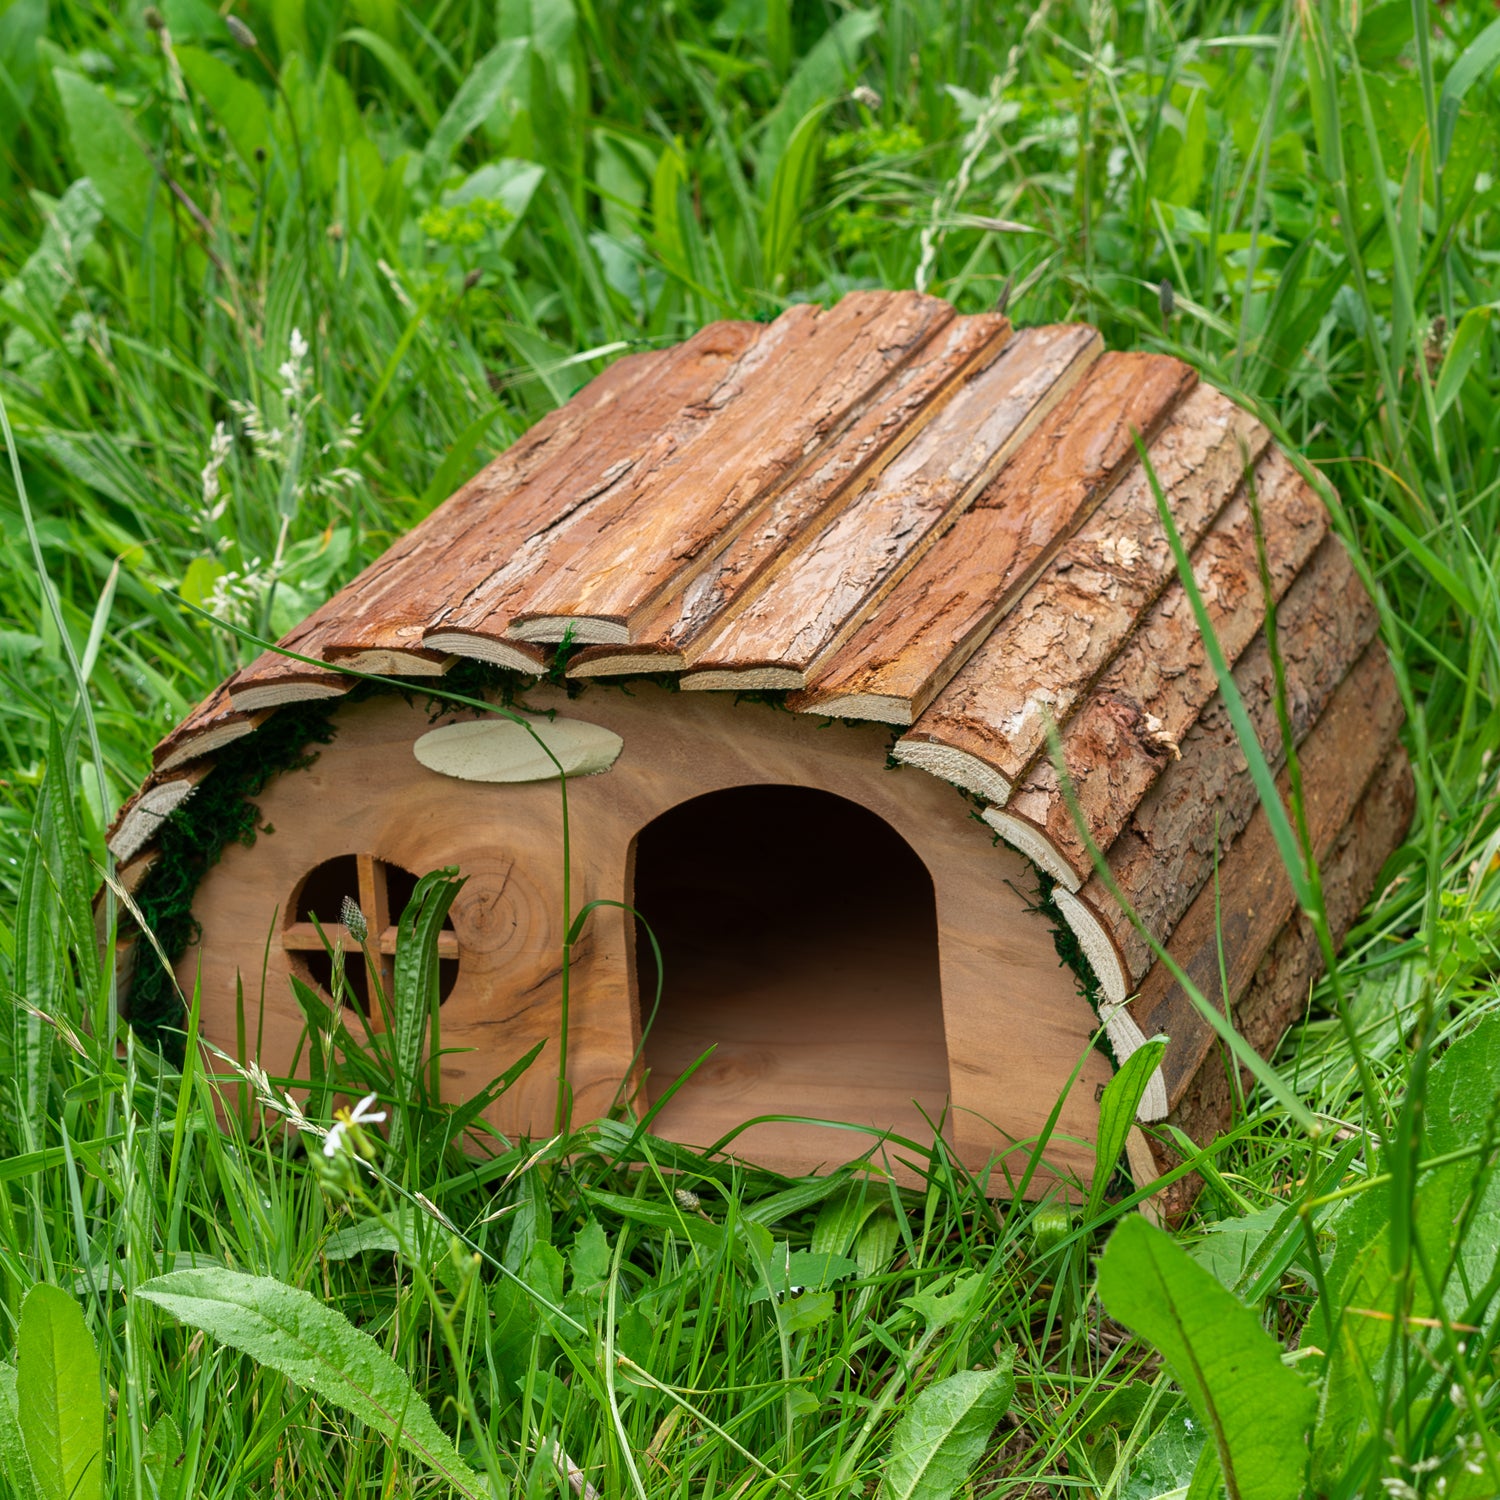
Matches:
[179,686,1110,1191]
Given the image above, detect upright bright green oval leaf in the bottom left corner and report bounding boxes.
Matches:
[15,1286,104,1500]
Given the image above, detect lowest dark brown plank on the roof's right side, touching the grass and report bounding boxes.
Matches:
[1152,746,1416,1223]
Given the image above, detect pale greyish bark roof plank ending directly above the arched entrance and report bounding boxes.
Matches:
[683,324,1100,689]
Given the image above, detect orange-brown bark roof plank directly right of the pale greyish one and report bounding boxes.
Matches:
[788,354,1197,725]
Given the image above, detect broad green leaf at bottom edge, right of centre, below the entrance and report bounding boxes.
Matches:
[881,1349,1016,1500]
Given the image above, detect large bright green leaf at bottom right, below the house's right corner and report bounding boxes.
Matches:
[1098,1218,1316,1500]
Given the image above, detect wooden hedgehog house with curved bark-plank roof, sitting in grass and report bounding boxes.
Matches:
[111,293,1412,1193]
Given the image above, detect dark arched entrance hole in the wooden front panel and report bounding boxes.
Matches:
[633,786,948,1172]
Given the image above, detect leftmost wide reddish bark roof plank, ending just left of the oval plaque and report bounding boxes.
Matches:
[240,333,744,698]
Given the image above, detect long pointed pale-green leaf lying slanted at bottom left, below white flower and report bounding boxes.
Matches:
[135,1269,494,1500]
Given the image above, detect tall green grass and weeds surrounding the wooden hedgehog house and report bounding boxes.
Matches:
[0,0,1500,1500]
